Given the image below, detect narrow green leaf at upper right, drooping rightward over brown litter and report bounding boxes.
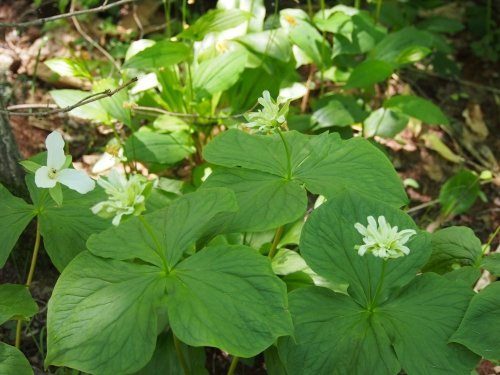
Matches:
[384,95,449,125]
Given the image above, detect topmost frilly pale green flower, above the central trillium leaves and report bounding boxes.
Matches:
[245,90,290,132]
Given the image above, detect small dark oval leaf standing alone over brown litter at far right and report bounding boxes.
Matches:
[439,170,481,215]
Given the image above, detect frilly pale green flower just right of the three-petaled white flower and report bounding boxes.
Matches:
[92,169,151,226]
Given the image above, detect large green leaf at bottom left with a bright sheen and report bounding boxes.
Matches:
[45,252,165,375]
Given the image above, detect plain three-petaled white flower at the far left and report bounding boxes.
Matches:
[35,131,95,194]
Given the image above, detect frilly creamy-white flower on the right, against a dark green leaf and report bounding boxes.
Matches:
[354,216,417,259]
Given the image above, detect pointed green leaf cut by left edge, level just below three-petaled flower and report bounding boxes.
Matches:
[0,184,35,268]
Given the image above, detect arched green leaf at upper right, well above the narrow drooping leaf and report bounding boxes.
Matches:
[369,26,433,64]
